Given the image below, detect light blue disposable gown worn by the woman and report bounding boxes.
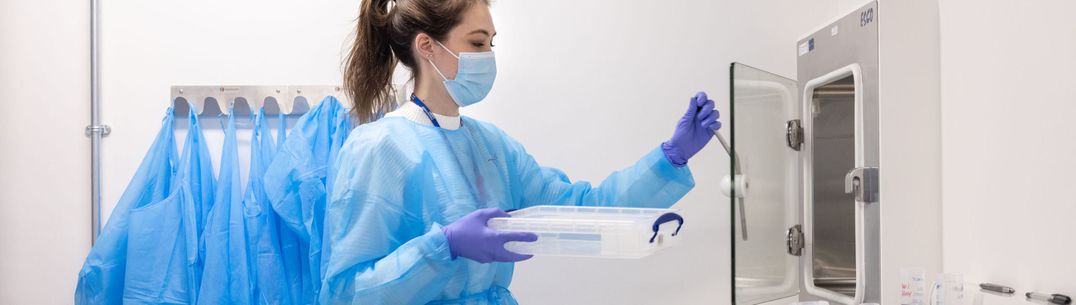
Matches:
[320,117,694,304]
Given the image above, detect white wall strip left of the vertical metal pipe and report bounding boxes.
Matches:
[0,0,90,304]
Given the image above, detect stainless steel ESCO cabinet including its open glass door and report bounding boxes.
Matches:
[727,2,883,305]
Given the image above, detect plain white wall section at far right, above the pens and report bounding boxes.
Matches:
[940,0,1076,304]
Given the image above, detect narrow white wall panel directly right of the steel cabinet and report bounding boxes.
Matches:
[878,0,943,304]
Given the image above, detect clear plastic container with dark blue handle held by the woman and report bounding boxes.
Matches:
[489,206,683,259]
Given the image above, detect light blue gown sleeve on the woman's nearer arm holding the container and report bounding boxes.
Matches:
[321,133,459,304]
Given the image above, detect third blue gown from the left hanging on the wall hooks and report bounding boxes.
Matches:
[198,115,254,305]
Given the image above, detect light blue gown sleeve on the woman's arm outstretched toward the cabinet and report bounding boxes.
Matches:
[505,132,695,208]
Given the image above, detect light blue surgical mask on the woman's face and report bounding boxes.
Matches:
[426,41,497,107]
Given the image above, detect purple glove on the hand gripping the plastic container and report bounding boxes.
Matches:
[442,208,538,263]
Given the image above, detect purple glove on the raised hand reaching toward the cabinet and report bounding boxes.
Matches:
[662,92,721,167]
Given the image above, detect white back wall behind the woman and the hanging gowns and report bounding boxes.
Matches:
[0,0,862,304]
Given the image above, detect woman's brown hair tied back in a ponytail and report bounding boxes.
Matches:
[343,0,489,123]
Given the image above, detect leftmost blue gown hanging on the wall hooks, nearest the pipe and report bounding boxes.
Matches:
[74,108,176,305]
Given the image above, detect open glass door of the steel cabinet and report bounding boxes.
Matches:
[730,64,802,305]
